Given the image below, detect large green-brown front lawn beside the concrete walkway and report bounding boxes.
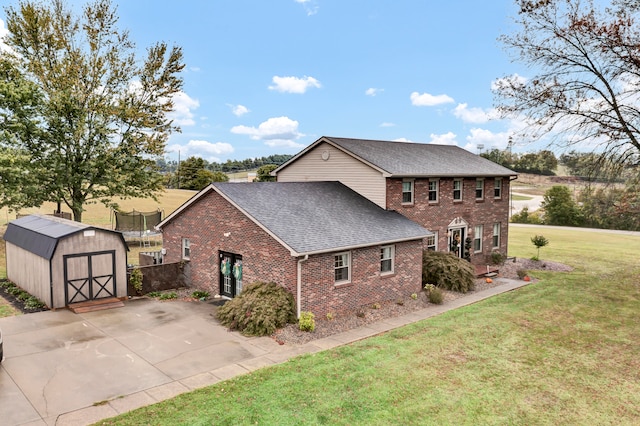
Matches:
[100,226,640,425]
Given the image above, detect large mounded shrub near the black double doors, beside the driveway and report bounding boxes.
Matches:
[217,282,296,336]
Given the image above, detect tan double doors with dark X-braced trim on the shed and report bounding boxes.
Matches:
[63,250,116,305]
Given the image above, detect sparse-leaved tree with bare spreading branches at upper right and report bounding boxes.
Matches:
[494,0,640,162]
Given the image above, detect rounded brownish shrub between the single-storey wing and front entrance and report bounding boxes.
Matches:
[422,250,475,293]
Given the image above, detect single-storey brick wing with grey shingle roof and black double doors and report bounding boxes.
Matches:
[157,181,431,316]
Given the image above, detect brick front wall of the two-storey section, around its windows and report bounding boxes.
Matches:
[387,178,510,265]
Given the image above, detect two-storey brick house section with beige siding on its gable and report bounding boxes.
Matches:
[273,137,517,265]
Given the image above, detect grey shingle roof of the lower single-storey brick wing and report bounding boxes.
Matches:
[157,182,431,256]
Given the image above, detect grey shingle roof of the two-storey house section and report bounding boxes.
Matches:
[273,136,517,177]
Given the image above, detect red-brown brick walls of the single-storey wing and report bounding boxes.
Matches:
[163,191,422,316]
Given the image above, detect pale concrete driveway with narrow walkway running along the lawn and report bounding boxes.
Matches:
[0,278,528,425]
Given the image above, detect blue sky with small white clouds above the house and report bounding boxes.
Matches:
[0,0,537,162]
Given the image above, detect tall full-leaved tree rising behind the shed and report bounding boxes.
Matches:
[0,0,184,221]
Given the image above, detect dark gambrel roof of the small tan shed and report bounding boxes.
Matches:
[4,214,129,260]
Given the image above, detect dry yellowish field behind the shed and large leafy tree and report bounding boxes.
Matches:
[0,189,196,278]
